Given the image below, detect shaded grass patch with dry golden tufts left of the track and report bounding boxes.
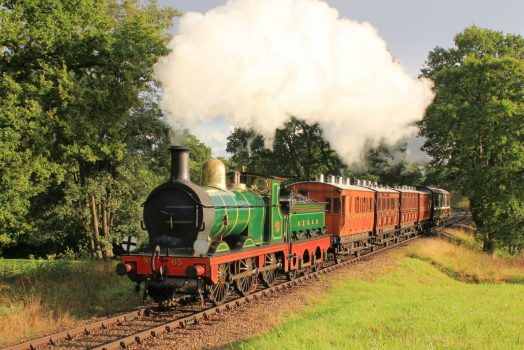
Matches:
[0,259,141,346]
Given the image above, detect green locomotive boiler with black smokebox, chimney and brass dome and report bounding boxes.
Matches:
[144,147,268,255]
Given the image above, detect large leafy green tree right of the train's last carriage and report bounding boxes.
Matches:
[421,26,524,251]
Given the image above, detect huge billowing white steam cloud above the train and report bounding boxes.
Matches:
[155,0,433,163]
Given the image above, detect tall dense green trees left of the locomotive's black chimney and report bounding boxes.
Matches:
[0,0,177,258]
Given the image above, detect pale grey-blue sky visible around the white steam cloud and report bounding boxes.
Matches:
[160,0,524,160]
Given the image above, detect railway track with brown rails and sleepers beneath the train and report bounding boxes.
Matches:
[4,212,467,350]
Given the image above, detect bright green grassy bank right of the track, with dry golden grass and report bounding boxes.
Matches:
[230,239,524,349]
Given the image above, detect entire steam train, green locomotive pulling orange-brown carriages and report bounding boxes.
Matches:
[116,147,449,305]
